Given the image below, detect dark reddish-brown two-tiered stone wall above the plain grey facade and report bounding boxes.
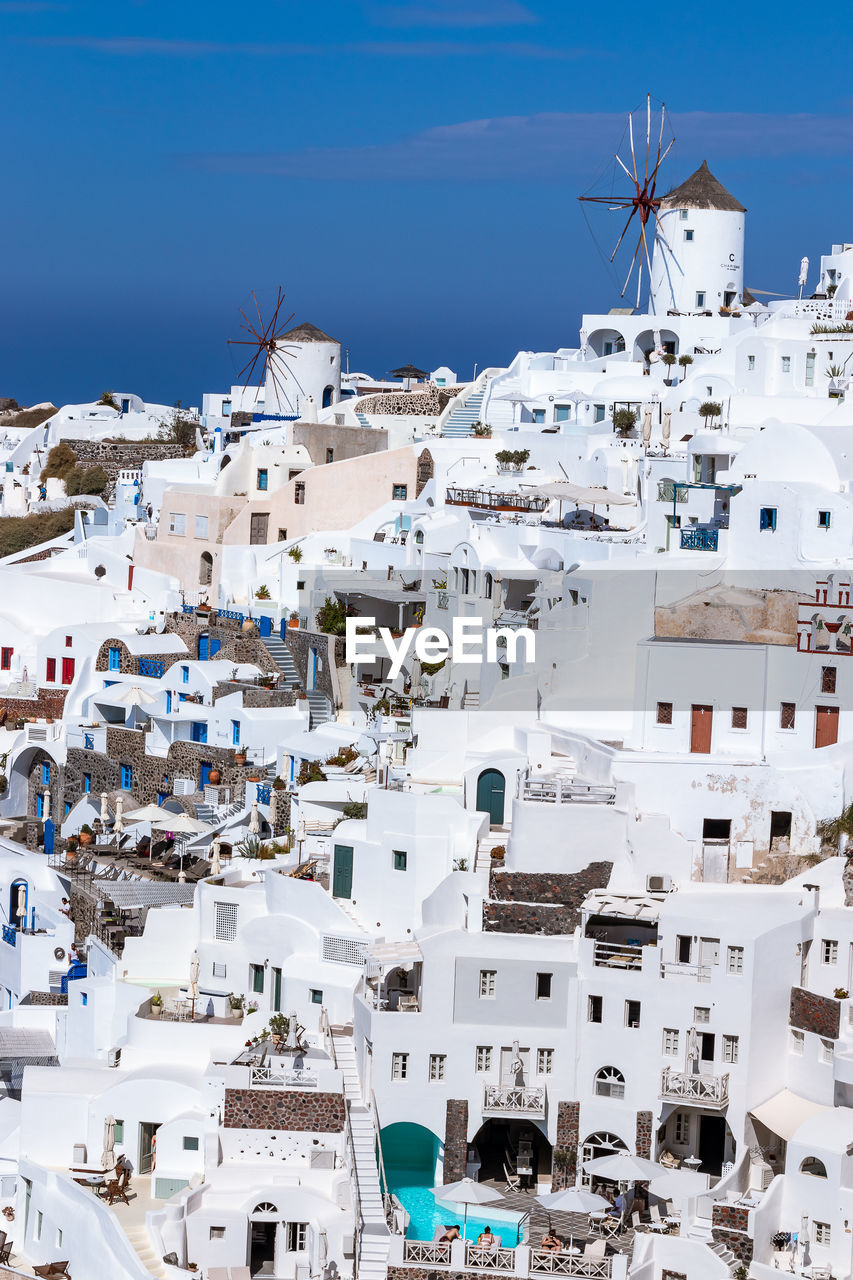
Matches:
[483,863,613,937]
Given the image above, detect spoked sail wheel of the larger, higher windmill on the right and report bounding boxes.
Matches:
[578,95,675,310]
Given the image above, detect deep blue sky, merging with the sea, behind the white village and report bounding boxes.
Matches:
[0,0,853,404]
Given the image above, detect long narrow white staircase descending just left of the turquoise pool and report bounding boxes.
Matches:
[332,1027,391,1280]
